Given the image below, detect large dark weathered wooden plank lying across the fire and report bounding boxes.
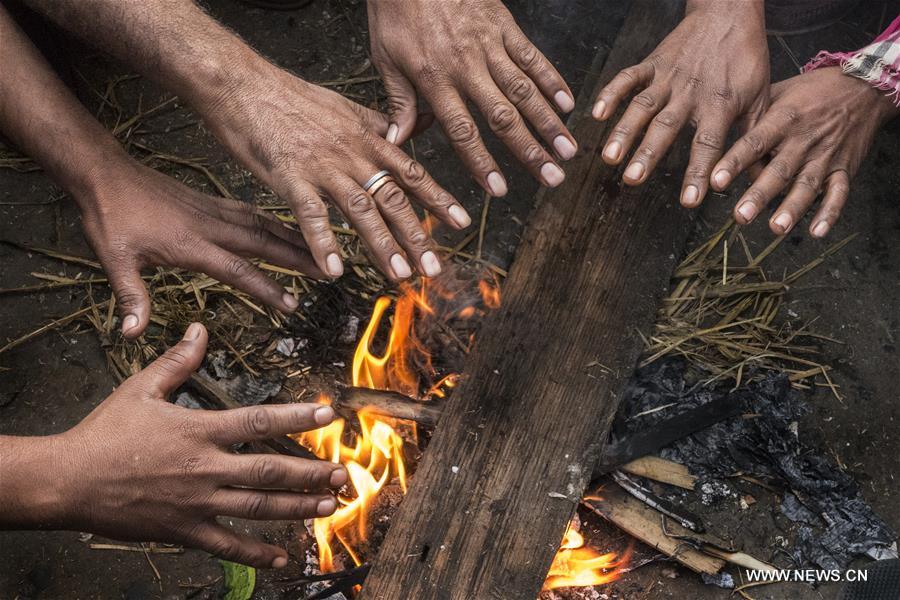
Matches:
[360,0,690,600]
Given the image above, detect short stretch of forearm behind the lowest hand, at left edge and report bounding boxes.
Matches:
[0,436,70,530]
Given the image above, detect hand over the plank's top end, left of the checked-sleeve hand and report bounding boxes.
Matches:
[593,0,769,207]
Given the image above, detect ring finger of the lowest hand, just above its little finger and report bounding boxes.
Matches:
[209,488,337,521]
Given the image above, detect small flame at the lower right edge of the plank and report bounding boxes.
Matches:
[544,523,628,590]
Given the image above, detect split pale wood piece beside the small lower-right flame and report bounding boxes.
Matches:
[585,484,725,575]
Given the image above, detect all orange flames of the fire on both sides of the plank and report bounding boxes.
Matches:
[297,270,627,590]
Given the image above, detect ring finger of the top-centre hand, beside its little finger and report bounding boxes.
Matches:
[488,58,578,160]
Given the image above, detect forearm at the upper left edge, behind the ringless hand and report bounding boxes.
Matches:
[0,6,125,202]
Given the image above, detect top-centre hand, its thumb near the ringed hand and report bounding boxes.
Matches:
[368,0,577,196]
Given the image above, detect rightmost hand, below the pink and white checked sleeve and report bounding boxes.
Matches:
[712,67,900,238]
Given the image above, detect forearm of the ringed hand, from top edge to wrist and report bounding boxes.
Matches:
[19,0,272,113]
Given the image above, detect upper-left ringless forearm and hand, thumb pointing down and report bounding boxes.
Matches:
[0,7,323,338]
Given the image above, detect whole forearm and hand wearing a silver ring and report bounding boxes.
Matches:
[26,0,471,280]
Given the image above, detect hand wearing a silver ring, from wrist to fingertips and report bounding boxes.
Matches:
[197,67,471,281]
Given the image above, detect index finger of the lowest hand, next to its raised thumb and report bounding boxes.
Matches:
[206,403,334,446]
